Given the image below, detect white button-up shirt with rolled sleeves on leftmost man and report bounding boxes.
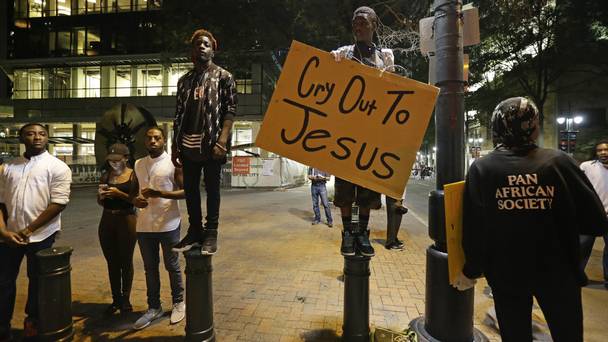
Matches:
[0,151,72,242]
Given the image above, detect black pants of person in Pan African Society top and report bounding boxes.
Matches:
[492,271,583,342]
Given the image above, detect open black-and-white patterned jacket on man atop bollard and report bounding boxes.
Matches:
[173,63,237,151]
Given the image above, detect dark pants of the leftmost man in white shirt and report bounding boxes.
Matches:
[0,234,55,331]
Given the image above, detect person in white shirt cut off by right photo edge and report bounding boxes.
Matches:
[580,140,608,289]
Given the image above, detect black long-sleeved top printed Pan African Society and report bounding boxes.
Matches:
[463,147,608,290]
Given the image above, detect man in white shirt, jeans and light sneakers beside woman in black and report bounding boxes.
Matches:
[131,127,186,330]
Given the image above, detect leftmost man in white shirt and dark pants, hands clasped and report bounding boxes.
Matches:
[0,123,72,340]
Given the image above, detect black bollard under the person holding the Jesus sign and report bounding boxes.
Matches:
[342,254,371,342]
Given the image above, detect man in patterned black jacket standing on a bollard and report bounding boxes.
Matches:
[171,29,236,254]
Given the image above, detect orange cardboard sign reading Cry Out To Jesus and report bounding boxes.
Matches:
[256,41,439,198]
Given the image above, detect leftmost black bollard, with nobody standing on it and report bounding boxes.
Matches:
[36,247,74,341]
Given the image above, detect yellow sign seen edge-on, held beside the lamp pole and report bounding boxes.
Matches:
[443,181,464,284]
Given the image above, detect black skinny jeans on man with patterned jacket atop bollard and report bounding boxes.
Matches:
[182,158,222,231]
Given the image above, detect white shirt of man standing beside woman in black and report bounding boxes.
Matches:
[135,152,181,233]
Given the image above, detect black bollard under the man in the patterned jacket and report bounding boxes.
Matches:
[184,247,215,342]
